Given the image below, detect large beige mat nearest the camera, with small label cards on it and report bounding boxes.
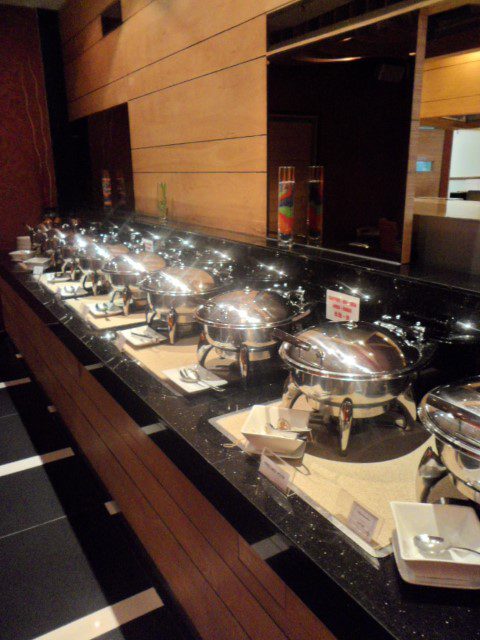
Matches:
[210,409,433,557]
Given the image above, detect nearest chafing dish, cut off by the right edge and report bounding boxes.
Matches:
[418,377,480,503]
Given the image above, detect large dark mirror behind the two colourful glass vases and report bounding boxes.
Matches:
[268,12,418,261]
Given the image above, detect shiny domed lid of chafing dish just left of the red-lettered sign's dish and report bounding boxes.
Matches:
[196,287,293,329]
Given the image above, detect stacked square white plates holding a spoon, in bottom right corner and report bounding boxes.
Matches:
[391,502,480,589]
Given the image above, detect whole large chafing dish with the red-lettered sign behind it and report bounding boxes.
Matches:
[280,321,434,452]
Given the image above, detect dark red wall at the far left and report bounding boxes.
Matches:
[0,6,56,249]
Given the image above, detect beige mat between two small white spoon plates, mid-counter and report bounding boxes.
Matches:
[123,336,202,384]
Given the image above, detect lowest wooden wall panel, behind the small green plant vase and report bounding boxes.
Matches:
[133,173,267,236]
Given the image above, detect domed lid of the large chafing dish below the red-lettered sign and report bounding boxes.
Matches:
[280,322,427,380]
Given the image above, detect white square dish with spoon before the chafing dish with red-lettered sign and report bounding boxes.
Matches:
[242,404,309,458]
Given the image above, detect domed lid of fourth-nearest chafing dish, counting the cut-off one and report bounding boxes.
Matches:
[142,266,217,295]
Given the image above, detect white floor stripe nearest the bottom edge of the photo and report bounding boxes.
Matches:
[35,587,163,640]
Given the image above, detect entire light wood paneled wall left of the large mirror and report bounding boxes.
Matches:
[60,0,291,235]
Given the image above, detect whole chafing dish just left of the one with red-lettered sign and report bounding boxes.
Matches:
[195,286,311,380]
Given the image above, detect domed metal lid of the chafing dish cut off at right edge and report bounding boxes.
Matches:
[418,378,480,457]
